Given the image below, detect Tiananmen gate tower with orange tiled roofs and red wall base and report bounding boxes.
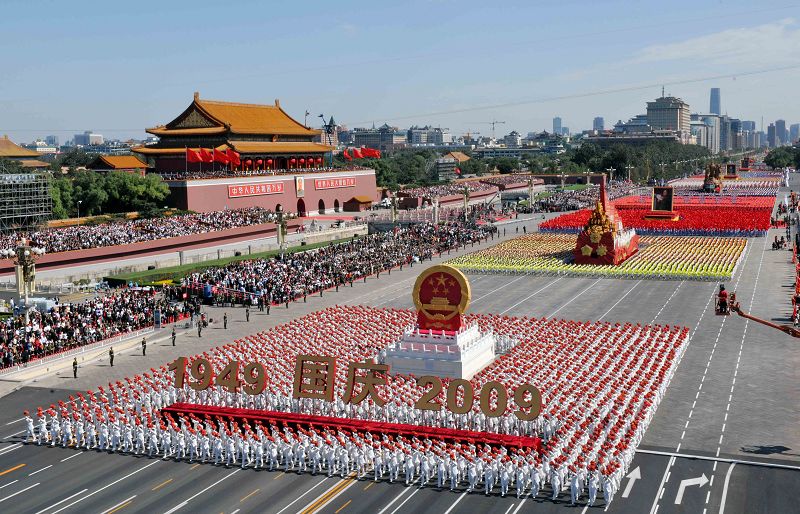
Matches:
[132,93,377,215]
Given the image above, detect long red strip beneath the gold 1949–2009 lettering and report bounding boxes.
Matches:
[161,403,542,452]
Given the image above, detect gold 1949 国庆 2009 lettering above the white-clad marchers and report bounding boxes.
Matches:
[169,355,542,421]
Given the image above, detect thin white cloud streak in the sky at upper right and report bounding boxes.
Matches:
[631,18,800,69]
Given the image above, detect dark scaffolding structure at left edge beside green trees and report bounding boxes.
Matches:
[0,165,53,234]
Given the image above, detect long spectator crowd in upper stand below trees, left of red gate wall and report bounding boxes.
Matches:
[0,207,288,253]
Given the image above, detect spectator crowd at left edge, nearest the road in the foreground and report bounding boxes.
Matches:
[0,289,166,368]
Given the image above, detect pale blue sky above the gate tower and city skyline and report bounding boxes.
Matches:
[0,0,800,142]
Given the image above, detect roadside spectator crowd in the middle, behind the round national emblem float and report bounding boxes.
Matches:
[184,223,493,305]
